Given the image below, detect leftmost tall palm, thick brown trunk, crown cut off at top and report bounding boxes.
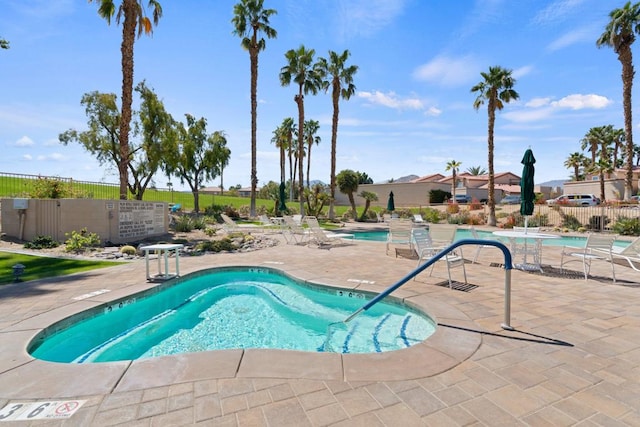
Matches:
[89,0,162,200]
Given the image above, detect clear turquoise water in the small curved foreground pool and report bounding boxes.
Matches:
[28,267,435,363]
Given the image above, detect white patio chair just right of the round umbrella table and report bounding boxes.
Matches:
[560,233,616,283]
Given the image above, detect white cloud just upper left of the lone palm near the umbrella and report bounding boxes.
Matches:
[413,55,481,87]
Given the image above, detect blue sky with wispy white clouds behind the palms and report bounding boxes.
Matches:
[0,0,638,188]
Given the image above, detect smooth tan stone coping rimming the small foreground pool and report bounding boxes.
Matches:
[0,263,482,398]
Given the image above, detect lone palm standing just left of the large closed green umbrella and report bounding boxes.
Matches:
[471,66,520,226]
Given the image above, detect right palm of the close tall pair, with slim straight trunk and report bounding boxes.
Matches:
[319,50,358,220]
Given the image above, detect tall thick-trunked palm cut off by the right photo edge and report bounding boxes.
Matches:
[596,2,640,200]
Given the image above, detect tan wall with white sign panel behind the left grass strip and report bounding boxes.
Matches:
[0,199,169,243]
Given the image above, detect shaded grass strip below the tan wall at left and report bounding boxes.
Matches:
[0,251,122,286]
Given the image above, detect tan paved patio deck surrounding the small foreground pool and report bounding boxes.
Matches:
[0,226,640,426]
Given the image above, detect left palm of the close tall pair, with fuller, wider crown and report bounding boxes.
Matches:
[280,45,324,215]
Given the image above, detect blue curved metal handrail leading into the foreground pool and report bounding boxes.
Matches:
[343,239,513,330]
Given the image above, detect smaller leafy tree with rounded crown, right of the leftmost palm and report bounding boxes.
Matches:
[165,114,230,213]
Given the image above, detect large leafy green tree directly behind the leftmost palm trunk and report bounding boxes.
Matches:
[58,86,174,200]
